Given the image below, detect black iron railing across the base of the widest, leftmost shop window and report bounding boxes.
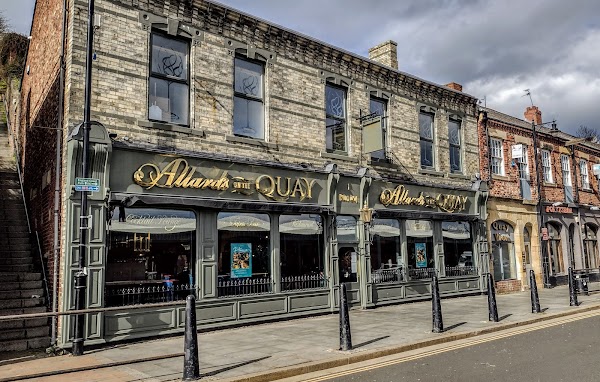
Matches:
[105,284,198,306]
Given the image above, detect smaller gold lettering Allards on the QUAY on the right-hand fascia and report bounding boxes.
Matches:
[379,185,467,212]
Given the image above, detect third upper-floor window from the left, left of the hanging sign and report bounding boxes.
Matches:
[325,83,347,152]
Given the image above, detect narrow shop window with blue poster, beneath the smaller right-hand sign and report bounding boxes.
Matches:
[406,220,435,279]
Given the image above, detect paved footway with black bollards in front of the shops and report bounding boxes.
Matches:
[0,284,600,382]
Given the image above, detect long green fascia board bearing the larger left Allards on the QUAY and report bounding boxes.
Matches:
[110,150,327,204]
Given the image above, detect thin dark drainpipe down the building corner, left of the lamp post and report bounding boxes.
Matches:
[51,0,67,346]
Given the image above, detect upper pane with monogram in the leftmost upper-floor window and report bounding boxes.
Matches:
[152,34,188,80]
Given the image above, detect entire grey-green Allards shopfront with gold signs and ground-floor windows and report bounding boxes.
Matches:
[59,139,486,347]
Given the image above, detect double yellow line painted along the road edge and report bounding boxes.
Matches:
[296,311,600,382]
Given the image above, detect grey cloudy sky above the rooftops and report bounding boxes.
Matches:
[0,0,600,133]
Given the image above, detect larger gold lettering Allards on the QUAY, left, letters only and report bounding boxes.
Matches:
[133,158,317,201]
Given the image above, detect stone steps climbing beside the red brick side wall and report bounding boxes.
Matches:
[0,121,50,352]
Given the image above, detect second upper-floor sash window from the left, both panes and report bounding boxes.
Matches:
[233,57,265,139]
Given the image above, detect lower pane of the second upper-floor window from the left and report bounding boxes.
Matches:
[233,97,265,139]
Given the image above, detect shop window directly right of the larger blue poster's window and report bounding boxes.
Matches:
[279,214,327,291]
